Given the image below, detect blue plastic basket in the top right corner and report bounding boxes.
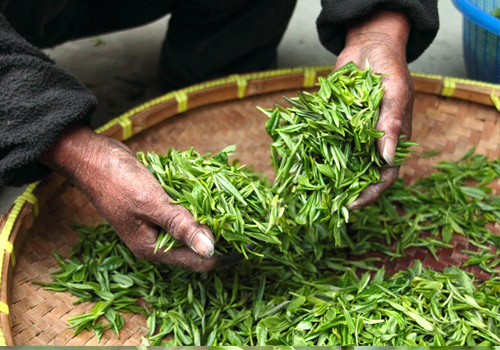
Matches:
[452,0,500,83]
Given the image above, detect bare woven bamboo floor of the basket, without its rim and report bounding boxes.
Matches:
[3,85,500,346]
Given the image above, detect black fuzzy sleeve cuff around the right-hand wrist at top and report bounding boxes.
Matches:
[316,0,439,62]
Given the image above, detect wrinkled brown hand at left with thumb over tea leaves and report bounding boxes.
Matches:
[40,125,222,272]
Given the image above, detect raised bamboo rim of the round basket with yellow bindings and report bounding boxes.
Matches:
[0,65,500,346]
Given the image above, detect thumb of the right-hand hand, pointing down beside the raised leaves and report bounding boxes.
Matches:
[376,71,413,165]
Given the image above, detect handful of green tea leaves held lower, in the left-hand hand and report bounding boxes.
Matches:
[137,146,284,257]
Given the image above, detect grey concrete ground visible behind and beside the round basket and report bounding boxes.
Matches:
[0,0,466,214]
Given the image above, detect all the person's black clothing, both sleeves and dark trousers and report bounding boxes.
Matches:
[0,0,439,186]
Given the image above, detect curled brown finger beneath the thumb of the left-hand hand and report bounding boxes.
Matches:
[124,223,224,272]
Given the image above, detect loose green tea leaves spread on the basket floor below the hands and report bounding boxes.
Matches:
[38,152,500,346]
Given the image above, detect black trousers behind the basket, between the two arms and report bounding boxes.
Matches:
[160,0,296,90]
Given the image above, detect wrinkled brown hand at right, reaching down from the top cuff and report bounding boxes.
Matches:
[334,11,413,209]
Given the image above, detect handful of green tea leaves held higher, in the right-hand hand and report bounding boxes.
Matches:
[261,62,415,244]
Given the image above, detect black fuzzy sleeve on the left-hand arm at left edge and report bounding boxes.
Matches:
[0,14,97,186]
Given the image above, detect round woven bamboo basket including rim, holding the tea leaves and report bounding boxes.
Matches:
[0,66,500,346]
